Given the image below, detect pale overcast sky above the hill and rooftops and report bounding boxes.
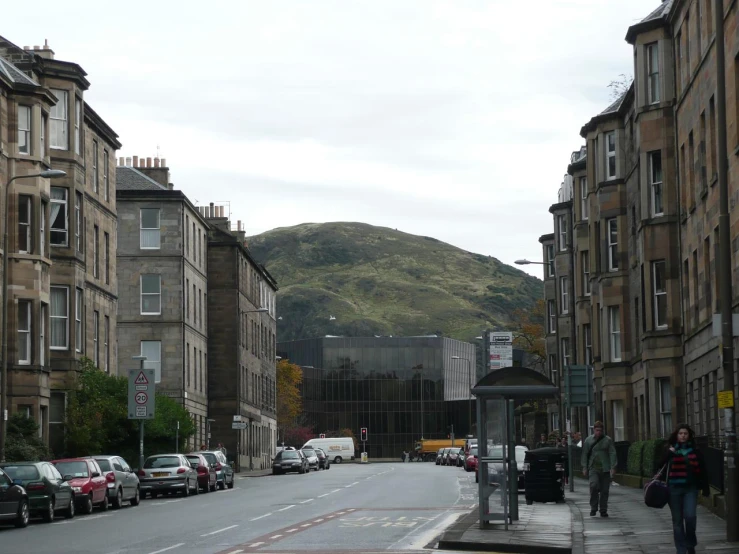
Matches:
[0,0,660,277]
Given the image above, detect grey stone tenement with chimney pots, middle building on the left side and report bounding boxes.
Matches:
[116,156,208,448]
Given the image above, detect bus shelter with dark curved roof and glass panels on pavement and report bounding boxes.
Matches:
[472,367,559,530]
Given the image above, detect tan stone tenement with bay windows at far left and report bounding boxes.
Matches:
[0,37,120,451]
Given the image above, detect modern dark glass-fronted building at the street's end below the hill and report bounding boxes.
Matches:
[277,336,477,458]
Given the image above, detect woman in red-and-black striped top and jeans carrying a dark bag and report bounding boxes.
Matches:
[660,423,711,554]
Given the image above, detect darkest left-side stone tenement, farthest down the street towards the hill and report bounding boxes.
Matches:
[200,204,277,469]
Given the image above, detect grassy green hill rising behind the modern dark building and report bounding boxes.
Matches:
[248,223,543,341]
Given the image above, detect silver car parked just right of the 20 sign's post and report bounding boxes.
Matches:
[139,454,200,498]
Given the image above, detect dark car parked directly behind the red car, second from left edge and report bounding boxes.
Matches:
[0,462,75,522]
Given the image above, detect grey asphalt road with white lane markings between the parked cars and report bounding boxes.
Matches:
[0,463,476,554]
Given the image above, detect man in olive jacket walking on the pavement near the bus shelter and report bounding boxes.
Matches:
[581,421,617,517]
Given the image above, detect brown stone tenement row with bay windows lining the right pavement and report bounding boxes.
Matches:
[540,0,739,440]
